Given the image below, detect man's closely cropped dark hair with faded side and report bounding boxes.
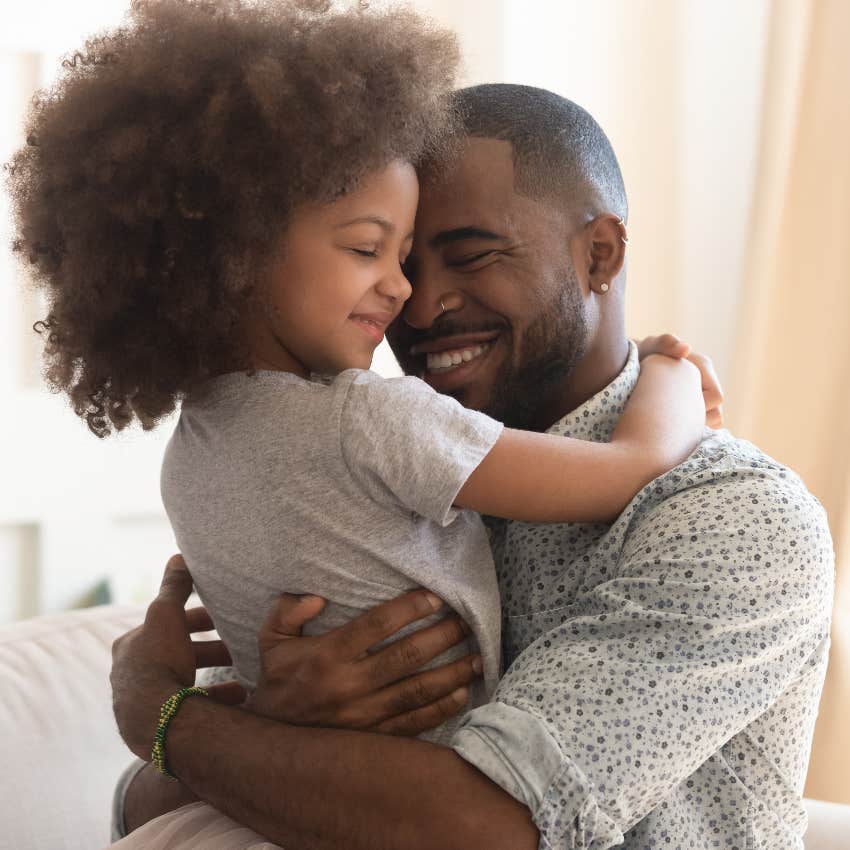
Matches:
[455,83,628,219]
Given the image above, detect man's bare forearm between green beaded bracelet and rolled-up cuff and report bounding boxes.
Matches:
[168,699,538,850]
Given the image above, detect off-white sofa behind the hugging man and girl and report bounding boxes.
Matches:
[0,605,850,850]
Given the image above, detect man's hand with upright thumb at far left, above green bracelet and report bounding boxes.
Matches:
[109,555,244,761]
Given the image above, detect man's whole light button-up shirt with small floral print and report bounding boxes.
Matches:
[453,345,834,850]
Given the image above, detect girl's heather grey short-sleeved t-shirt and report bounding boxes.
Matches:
[162,369,502,743]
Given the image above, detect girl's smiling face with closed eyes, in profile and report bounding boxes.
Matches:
[248,161,419,377]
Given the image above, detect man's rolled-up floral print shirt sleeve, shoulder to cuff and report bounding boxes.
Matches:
[453,466,834,848]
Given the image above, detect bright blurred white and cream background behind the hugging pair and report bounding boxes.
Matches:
[0,0,850,802]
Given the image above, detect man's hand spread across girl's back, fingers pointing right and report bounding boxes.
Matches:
[245,590,481,736]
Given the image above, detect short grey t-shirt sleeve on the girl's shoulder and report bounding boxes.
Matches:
[340,372,503,525]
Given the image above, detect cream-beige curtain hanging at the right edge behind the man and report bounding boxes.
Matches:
[729,0,850,803]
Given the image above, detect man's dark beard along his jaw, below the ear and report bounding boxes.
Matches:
[483,269,587,431]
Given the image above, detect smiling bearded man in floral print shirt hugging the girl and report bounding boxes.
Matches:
[113,85,832,850]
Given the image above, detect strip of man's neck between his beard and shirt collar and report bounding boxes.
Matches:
[535,333,629,431]
